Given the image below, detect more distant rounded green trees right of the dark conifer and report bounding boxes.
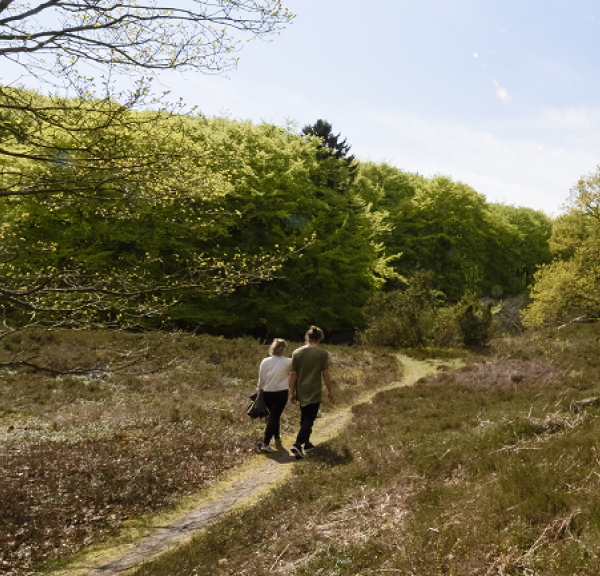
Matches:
[355,163,551,302]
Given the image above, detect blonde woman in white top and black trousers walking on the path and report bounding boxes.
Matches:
[256,338,292,453]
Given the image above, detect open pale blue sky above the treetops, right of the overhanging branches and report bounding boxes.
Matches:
[154,0,600,216]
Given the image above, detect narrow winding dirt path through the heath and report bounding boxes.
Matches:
[56,356,440,576]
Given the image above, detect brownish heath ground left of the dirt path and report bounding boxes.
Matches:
[0,331,398,574]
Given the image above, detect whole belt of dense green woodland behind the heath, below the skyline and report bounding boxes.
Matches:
[1,89,572,344]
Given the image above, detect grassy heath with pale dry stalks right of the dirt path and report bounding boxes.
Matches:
[127,324,600,576]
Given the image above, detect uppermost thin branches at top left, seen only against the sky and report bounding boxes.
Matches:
[0,0,293,81]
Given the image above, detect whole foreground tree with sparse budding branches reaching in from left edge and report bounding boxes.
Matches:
[0,0,293,344]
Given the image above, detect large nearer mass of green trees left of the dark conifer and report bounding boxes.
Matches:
[0,103,393,335]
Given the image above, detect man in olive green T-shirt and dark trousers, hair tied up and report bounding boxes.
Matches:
[289,326,333,459]
